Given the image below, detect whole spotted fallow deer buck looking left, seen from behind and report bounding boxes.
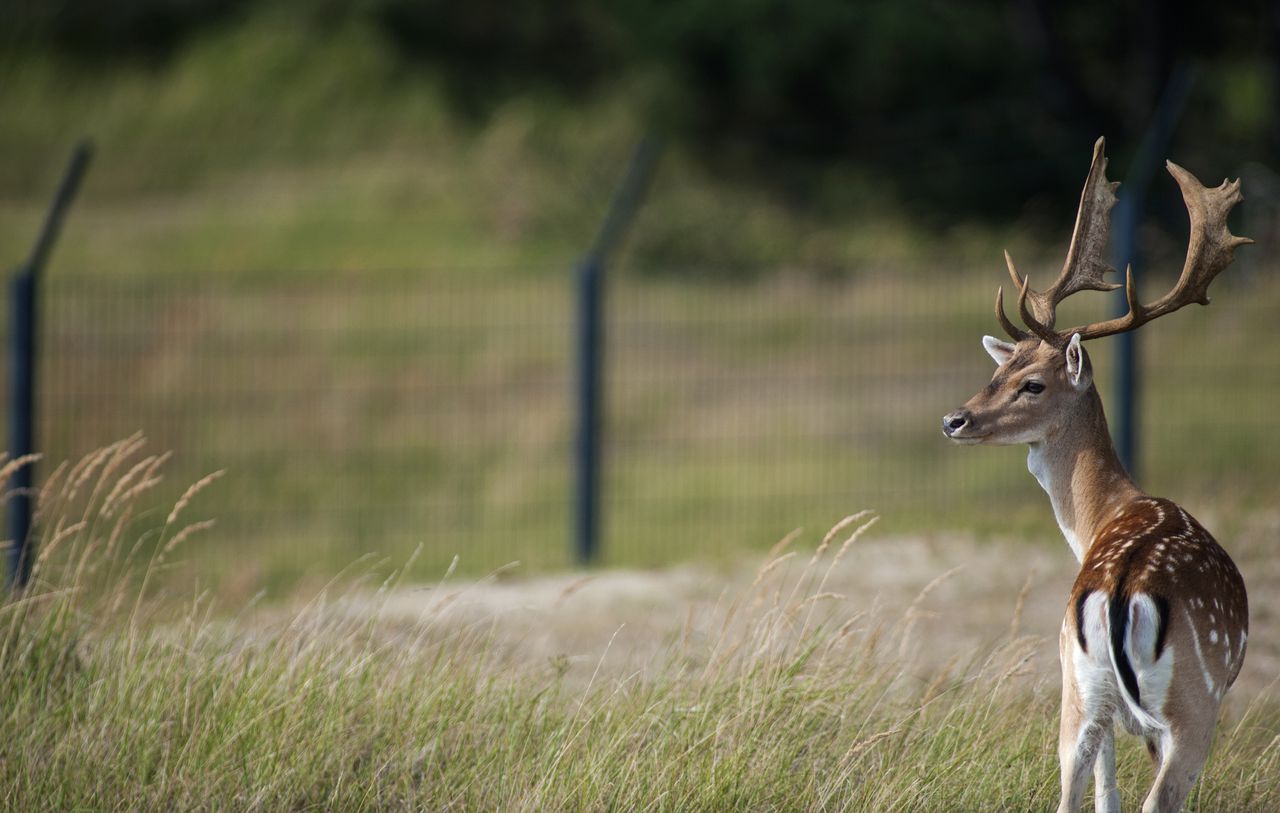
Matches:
[942,138,1252,813]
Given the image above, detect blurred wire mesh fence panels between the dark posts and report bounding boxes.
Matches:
[15,258,1280,579]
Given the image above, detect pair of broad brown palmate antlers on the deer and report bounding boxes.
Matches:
[996,138,1253,347]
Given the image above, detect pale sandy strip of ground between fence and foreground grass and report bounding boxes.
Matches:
[366,515,1280,704]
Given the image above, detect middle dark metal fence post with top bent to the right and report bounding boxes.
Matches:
[572,137,659,566]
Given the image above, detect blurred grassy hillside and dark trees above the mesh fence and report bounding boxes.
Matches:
[0,0,1280,273]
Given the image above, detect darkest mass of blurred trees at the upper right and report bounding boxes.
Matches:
[604,0,1277,216]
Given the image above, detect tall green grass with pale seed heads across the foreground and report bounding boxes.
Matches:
[0,458,1280,810]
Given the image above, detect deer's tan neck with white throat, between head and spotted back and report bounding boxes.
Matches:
[1027,385,1142,562]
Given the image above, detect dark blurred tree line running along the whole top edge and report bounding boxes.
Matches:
[9,0,1280,223]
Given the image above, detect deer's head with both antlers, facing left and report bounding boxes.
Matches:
[942,138,1253,444]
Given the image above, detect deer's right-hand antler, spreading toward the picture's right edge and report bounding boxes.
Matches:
[1068,161,1253,339]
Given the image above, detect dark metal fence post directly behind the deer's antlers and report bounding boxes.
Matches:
[1112,63,1194,480]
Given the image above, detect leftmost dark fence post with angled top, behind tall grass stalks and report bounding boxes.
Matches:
[6,141,93,589]
